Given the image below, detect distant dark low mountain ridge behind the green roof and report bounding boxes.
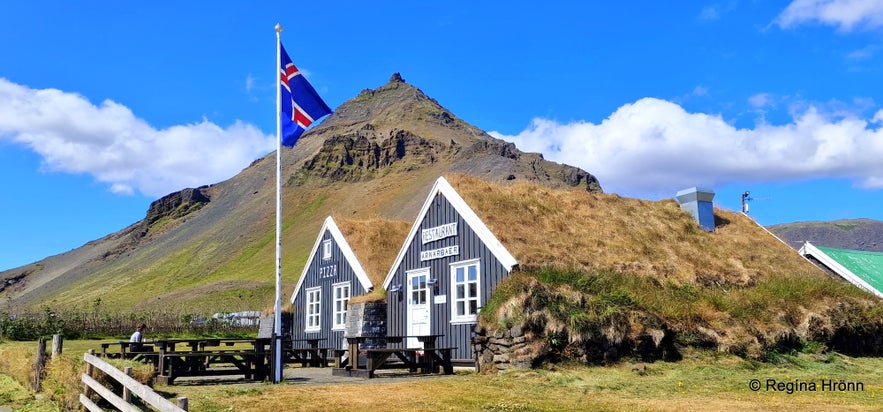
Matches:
[768,219,883,252]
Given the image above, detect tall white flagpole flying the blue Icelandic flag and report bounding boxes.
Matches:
[273,23,282,383]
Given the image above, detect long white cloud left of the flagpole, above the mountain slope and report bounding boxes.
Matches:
[0,78,275,200]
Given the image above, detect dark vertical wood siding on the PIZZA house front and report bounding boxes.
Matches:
[291,230,367,348]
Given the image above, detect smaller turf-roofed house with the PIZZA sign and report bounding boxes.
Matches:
[291,216,408,348]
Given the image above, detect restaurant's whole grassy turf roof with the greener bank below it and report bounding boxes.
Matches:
[449,175,881,357]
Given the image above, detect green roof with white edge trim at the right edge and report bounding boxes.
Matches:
[800,242,883,298]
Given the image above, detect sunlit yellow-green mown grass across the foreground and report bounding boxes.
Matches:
[0,341,883,412]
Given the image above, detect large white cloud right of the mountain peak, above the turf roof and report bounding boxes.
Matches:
[491,98,883,198]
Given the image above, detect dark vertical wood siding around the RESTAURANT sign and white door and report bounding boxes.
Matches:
[387,193,508,359]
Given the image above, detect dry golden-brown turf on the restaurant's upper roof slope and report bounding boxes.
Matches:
[449,175,821,286]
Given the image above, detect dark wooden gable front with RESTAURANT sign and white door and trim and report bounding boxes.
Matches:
[383,177,517,361]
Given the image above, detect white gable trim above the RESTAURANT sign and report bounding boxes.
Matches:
[383,177,518,289]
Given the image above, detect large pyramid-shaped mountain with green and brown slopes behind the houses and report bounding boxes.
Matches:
[0,73,601,313]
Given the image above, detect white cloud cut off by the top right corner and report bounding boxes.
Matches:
[776,0,883,31]
